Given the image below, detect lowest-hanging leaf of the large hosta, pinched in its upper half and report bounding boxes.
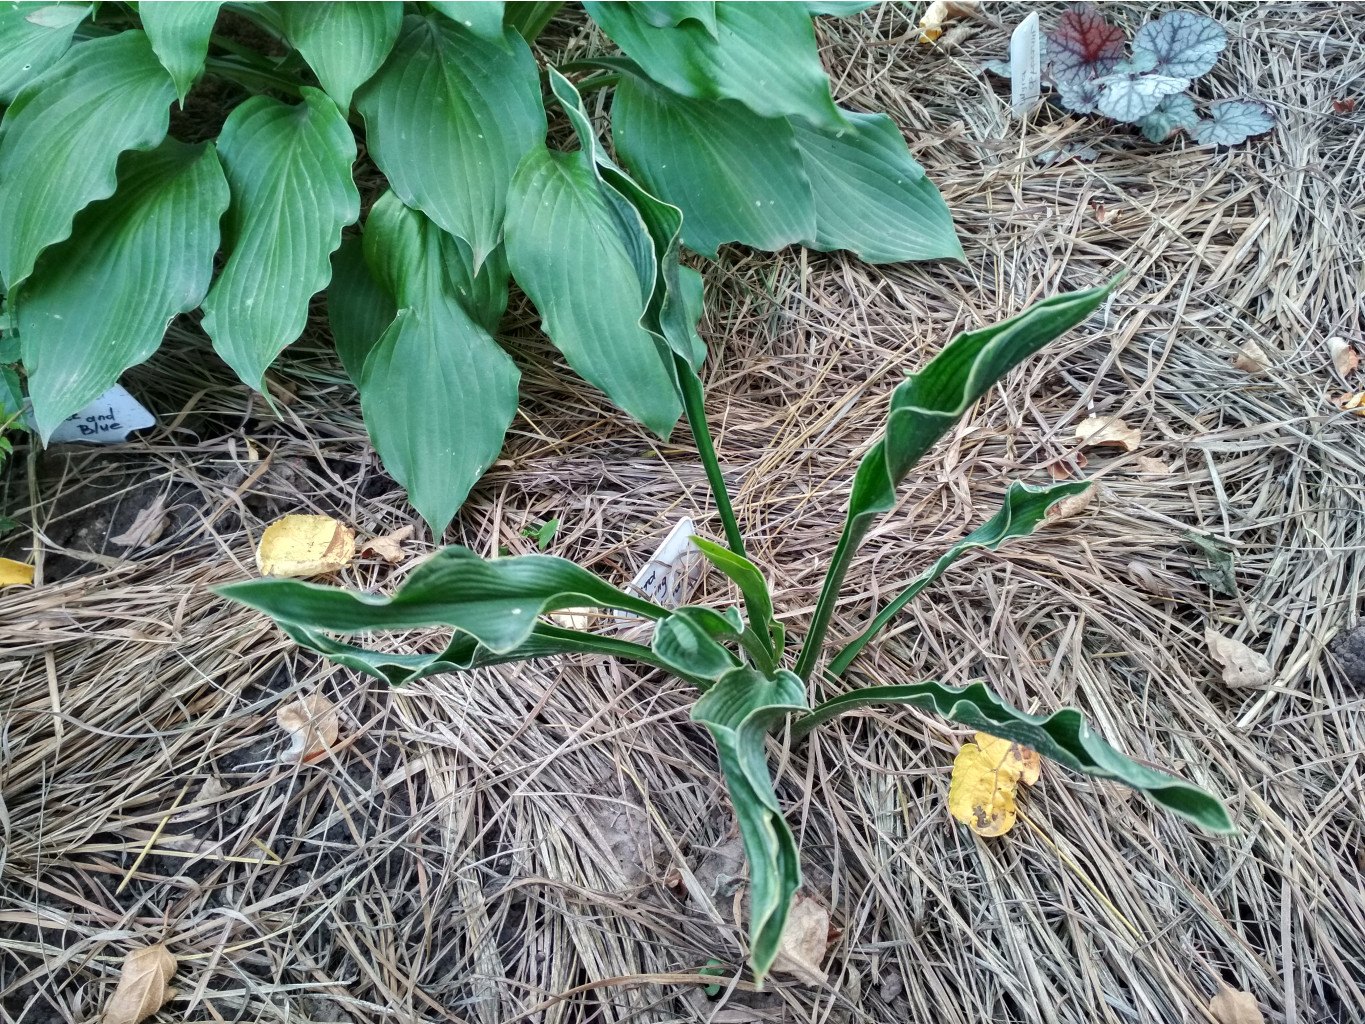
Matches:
[359,193,520,537]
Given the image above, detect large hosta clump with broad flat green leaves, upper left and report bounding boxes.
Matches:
[0,0,961,534]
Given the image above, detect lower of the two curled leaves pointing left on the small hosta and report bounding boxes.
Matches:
[280,621,682,687]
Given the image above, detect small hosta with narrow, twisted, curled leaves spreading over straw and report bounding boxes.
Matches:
[218,278,1231,980]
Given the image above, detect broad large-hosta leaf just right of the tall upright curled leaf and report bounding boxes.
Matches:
[612,75,816,257]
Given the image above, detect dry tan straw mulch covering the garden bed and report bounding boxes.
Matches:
[0,4,1365,1024]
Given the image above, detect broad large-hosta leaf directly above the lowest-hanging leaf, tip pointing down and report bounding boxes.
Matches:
[356,15,545,268]
